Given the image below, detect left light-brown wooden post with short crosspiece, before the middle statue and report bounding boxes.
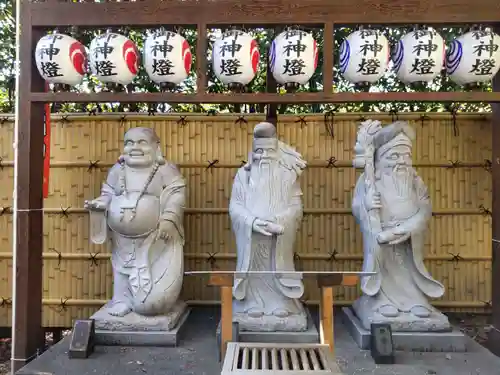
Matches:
[209,274,234,360]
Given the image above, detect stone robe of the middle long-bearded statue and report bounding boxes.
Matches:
[229,165,305,315]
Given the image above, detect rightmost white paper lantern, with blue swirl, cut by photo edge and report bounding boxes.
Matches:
[446,30,500,85]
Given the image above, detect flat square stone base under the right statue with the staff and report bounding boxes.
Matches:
[342,307,468,352]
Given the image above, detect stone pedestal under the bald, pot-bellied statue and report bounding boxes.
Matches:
[91,302,190,346]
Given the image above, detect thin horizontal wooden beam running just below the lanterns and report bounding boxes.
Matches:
[31,91,500,104]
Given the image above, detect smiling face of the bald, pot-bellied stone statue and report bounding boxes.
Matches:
[123,128,157,167]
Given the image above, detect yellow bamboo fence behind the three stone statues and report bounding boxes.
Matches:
[0,113,492,327]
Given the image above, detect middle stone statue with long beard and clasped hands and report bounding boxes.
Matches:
[229,123,307,331]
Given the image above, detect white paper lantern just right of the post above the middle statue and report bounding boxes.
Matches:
[269,29,318,86]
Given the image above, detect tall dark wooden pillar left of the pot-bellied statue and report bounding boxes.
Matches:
[12,1,45,371]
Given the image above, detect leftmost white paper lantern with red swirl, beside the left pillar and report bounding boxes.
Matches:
[35,33,87,86]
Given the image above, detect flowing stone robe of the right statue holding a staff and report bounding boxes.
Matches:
[352,173,444,328]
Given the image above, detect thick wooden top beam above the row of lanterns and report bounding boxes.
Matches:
[30,0,500,27]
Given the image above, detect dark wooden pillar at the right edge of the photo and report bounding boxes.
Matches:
[488,24,500,356]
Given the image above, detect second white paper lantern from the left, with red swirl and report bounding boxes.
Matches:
[89,32,139,85]
